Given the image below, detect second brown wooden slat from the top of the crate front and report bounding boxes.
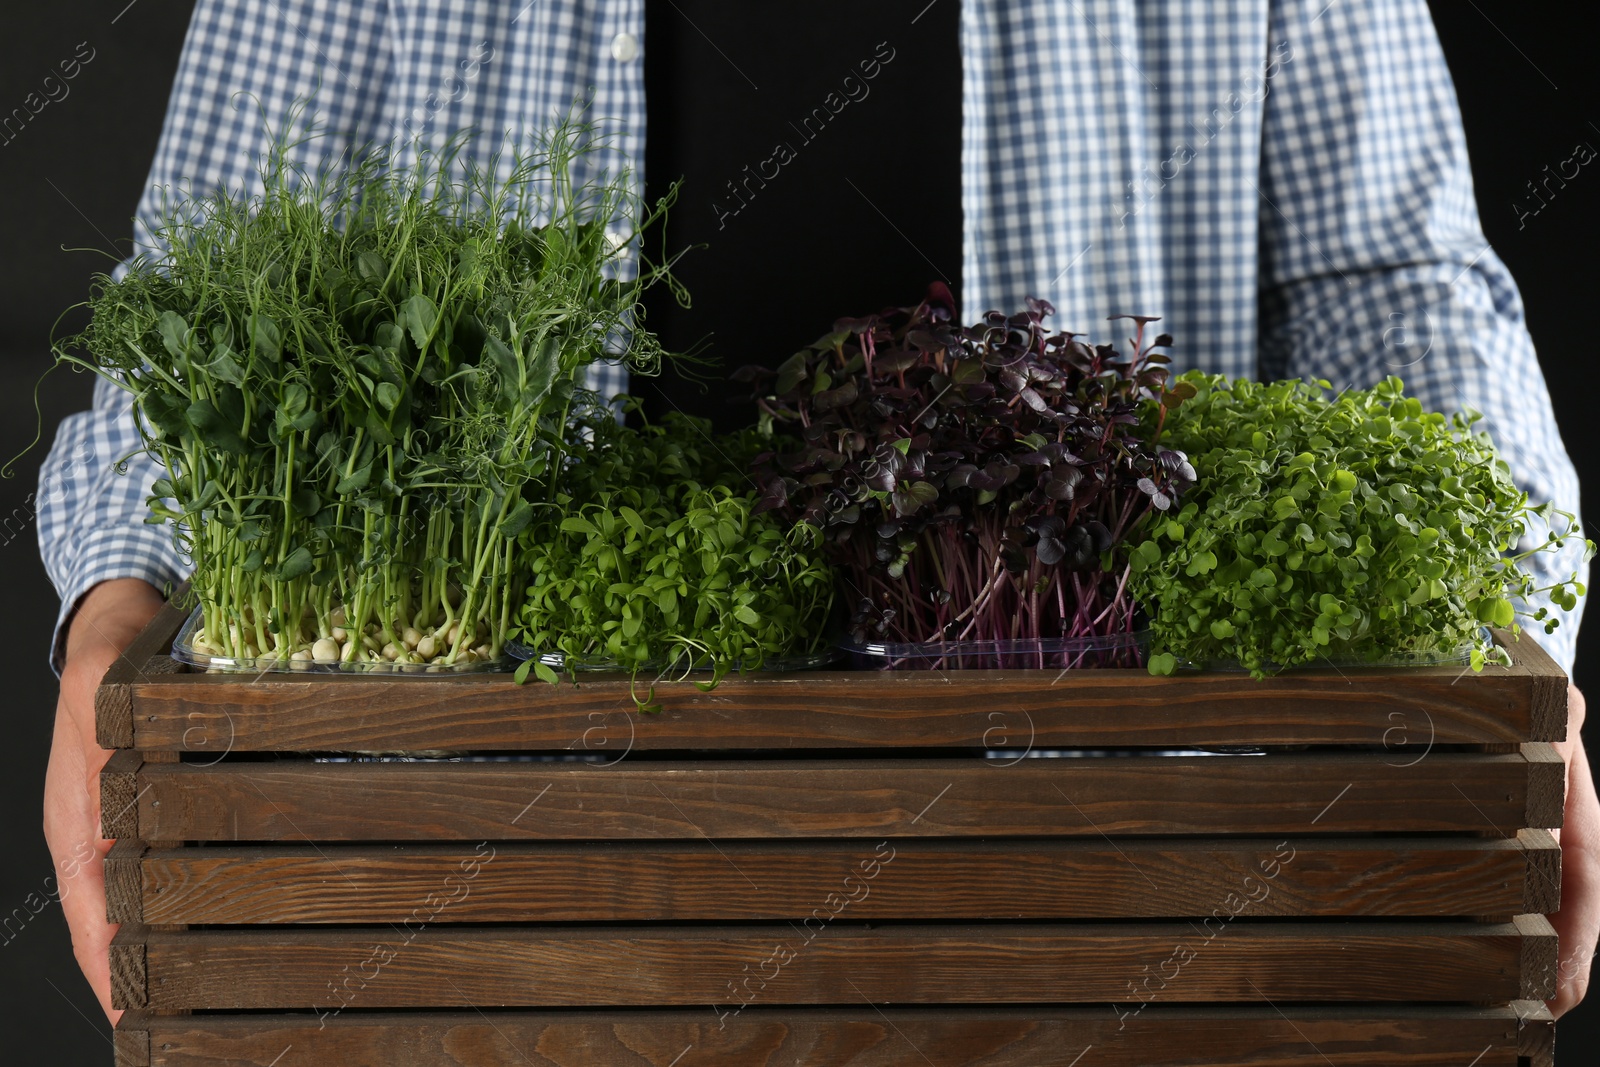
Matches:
[121,752,1560,841]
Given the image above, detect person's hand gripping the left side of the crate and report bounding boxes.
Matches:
[45,577,162,1025]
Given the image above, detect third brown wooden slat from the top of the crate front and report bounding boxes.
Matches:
[131,830,1560,925]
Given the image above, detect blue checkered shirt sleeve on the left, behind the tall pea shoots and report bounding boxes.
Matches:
[37,0,390,672]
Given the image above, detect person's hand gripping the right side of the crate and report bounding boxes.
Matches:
[1547,686,1600,1019]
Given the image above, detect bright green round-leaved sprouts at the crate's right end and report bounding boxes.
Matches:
[1133,371,1594,677]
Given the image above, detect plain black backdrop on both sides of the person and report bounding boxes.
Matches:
[0,0,1600,1065]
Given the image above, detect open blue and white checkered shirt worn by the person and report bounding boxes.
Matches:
[38,0,1582,669]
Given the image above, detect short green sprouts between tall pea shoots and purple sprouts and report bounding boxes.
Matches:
[512,413,834,710]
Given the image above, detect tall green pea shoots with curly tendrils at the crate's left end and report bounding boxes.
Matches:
[54,106,677,669]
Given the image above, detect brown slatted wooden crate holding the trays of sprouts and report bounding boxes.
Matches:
[98,611,1566,1067]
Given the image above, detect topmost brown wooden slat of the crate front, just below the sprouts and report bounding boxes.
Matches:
[133,652,1565,763]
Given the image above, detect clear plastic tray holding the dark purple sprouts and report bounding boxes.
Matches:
[840,630,1149,670]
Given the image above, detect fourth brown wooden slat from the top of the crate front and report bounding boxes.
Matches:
[131,917,1555,1011]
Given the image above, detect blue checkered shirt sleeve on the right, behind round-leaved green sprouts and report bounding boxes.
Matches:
[1259,0,1587,672]
